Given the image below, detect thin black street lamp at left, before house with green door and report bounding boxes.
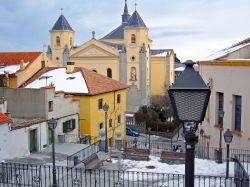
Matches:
[48,118,57,187]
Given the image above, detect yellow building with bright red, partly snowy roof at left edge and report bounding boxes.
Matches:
[0,52,56,88]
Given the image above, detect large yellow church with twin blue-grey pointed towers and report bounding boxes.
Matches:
[47,1,175,113]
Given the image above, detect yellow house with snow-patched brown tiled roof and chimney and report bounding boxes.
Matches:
[25,62,127,140]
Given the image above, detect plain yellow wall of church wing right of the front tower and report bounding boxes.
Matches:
[151,57,167,96]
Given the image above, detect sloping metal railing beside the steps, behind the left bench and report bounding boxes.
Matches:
[67,141,100,167]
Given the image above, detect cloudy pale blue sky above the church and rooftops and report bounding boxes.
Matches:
[0,0,250,61]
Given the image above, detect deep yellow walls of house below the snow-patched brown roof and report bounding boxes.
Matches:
[74,90,126,142]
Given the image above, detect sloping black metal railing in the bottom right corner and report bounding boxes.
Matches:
[233,155,250,187]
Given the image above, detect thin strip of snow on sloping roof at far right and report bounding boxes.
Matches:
[204,42,250,60]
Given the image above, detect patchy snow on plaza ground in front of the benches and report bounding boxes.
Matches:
[110,156,234,187]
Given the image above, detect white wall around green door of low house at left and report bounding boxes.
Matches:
[0,122,47,160]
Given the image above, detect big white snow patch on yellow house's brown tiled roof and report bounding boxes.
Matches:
[25,68,89,93]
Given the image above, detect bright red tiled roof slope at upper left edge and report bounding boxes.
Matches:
[0,52,42,66]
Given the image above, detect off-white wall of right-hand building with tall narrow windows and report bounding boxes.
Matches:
[199,65,250,150]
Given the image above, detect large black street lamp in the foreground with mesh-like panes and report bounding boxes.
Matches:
[168,60,211,187]
